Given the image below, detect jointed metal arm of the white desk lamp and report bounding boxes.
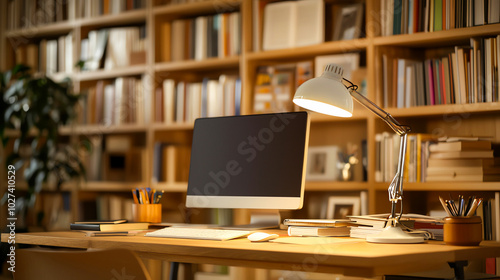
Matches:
[348,86,411,222]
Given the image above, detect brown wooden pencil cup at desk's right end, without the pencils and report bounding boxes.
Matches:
[443,216,483,246]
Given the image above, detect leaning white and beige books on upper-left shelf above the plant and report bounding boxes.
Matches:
[80,25,147,71]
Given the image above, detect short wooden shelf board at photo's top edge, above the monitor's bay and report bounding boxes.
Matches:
[153,0,242,18]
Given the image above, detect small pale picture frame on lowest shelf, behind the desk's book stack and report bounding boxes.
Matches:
[326,196,361,219]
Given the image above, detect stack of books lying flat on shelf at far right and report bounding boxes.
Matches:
[426,138,500,182]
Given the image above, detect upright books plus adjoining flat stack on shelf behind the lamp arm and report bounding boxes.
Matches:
[375,132,500,182]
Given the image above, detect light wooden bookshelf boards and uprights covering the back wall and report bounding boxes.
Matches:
[0,0,500,238]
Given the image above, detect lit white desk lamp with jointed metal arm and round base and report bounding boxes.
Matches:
[293,64,424,243]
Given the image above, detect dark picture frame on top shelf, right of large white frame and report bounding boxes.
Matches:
[332,3,363,41]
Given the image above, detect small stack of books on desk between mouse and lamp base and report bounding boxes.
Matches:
[283,219,352,237]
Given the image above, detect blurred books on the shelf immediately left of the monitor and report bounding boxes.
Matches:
[152,142,191,183]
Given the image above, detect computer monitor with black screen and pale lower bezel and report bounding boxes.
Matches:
[186,112,309,214]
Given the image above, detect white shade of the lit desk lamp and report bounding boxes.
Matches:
[293,64,353,118]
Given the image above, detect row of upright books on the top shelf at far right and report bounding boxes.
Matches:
[380,0,500,36]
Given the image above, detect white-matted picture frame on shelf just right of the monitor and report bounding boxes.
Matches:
[306,146,340,181]
